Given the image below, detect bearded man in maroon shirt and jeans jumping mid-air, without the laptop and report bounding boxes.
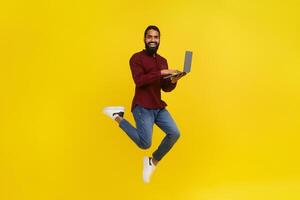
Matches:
[103,26,184,183]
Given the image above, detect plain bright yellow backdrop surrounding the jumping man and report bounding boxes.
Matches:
[0,0,300,200]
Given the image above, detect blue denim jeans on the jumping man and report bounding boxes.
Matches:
[119,106,180,161]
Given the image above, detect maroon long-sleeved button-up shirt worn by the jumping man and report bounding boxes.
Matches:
[129,50,176,110]
